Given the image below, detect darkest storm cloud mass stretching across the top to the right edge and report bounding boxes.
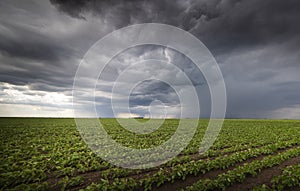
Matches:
[51,0,300,53]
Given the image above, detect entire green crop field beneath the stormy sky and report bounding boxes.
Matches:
[0,118,300,191]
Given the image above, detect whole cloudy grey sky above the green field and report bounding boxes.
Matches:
[0,0,300,119]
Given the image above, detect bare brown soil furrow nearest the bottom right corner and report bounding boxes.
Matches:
[226,156,300,191]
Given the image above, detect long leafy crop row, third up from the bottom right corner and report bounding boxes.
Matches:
[80,140,299,190]
